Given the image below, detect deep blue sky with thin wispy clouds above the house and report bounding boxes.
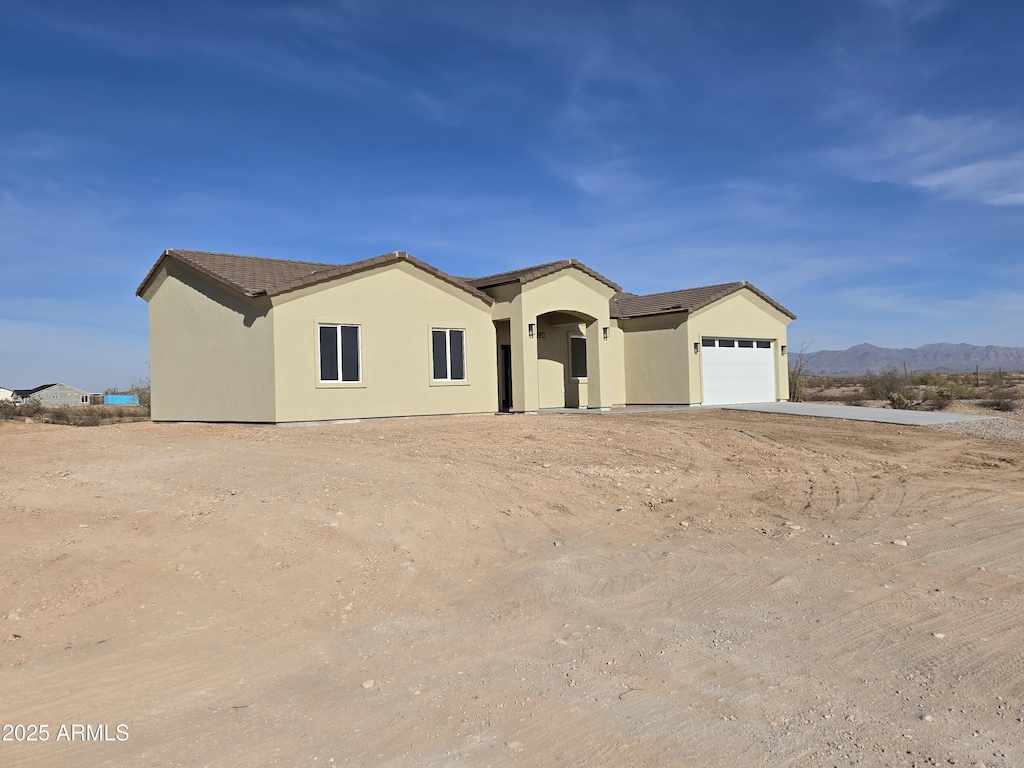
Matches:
[0,0,1024,390]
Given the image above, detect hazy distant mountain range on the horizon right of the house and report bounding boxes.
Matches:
[790,344,1024,376]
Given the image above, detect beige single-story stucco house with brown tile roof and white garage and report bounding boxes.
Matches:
[137,250,796,423]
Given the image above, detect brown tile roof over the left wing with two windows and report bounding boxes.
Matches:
[135,249,494,304]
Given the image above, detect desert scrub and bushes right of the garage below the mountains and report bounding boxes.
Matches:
[790,359,1024,416]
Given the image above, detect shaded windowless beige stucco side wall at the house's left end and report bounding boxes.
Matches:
[142,260,275,422]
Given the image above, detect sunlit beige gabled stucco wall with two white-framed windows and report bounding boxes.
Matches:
[273,262,498,422]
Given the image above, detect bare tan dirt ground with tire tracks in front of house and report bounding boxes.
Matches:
[0,410,1024,768]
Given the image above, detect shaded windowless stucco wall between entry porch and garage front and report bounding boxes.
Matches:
[620,312,695,406]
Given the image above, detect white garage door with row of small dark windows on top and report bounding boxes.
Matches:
[700,338,775,406]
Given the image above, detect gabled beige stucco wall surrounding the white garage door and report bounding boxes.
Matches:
[686,289,793,402]
